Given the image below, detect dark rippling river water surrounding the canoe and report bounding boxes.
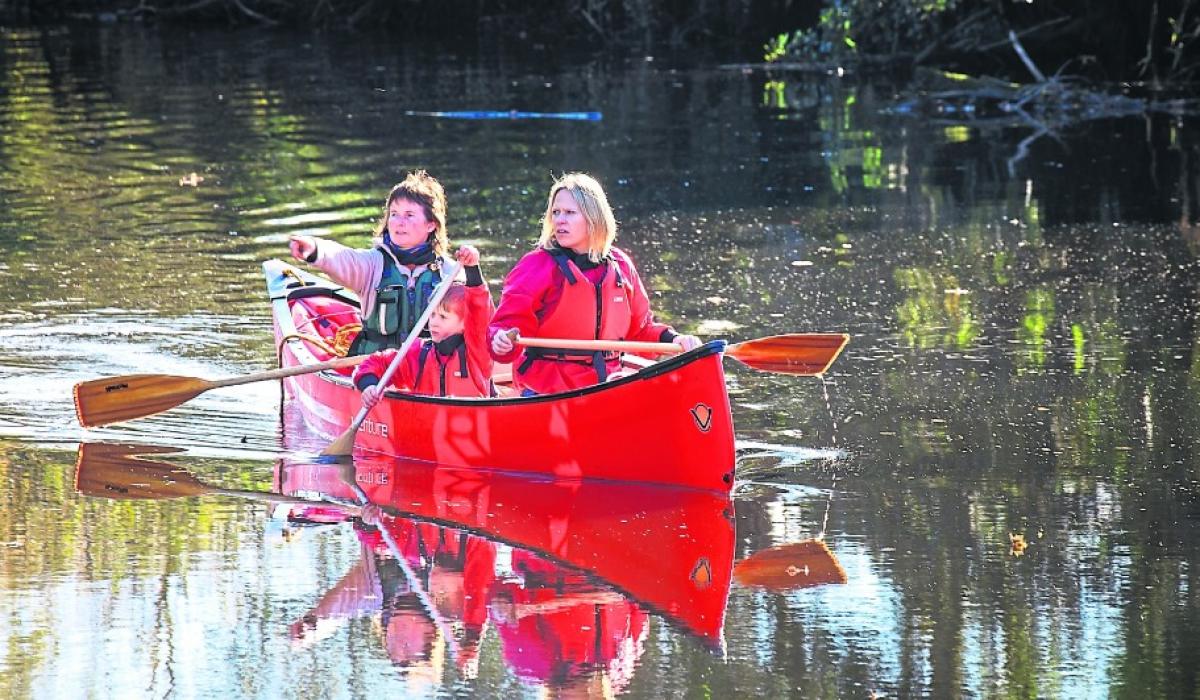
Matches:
[0,26,1200,698]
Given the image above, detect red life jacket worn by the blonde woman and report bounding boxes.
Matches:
[517,256,634,382]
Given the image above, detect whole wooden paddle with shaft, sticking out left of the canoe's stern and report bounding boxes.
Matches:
[74,355,366,427]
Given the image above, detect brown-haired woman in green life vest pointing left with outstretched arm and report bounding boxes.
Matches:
[289,170,458,355]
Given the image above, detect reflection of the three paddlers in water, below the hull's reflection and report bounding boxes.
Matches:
[278,505,649,696]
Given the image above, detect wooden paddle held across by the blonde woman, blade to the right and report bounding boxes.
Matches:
[515,333,850,377]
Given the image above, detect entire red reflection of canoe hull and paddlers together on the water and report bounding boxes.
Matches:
[276,460,734,692]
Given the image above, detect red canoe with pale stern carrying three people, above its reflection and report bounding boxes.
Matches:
[263,261,734,492]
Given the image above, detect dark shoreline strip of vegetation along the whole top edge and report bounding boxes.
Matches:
[9,0,1200,84]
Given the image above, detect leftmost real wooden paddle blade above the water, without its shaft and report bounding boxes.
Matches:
[74,375,212,427]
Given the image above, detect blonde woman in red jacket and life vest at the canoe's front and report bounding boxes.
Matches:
[488,173,700,395]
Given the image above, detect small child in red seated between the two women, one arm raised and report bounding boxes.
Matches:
[354,245,493,408]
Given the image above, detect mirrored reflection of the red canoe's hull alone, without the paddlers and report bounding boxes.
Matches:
[276,459,736,650]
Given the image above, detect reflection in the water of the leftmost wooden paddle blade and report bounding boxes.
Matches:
[76,443,210,499]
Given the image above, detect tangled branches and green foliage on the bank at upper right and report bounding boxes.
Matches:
[766,0,1200,82]
